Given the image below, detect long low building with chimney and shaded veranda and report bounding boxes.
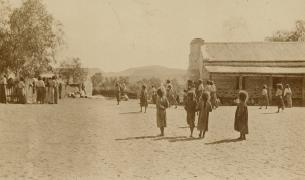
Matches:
[188,38,305,106]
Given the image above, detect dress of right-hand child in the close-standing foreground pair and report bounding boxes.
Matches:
[197,101,212,132]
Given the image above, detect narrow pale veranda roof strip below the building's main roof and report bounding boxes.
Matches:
[205,66,305,74]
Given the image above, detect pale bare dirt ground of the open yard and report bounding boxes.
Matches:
[0,99,305,180]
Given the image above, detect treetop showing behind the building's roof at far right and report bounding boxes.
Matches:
[265,20,305,42]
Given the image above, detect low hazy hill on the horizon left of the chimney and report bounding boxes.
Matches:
[105,66,186,81]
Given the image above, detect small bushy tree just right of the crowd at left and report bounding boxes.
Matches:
[59,58,88,83]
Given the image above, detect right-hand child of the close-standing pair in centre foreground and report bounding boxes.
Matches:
[197,91,212,138]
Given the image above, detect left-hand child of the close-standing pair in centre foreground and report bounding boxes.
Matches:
[184,85,197,137]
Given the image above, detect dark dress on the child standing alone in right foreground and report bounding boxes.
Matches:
[234,103,249,134]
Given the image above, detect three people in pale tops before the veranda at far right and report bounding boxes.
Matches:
[260,83,292,113]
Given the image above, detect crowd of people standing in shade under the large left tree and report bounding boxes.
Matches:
[0,75,63,104]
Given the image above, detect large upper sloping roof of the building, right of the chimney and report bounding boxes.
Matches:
[203,42,305,61]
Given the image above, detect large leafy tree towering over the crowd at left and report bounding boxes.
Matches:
[5,0,63,76]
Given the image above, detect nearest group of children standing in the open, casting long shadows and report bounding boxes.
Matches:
[151,80,248,140]
